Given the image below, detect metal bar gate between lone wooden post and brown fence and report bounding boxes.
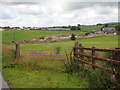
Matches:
[20,49,72,60]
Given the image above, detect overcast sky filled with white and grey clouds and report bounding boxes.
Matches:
[0,0,118,27]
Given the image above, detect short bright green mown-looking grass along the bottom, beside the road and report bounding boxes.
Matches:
[3,68,88,88]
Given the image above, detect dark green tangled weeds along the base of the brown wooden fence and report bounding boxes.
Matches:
[64,51,117,88]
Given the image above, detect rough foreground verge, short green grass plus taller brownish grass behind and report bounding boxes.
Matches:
[3,49,89,88]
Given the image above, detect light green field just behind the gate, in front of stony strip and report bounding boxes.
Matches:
[7,36,118,50]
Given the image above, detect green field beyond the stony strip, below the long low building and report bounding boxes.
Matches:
[2,30,85,42]
